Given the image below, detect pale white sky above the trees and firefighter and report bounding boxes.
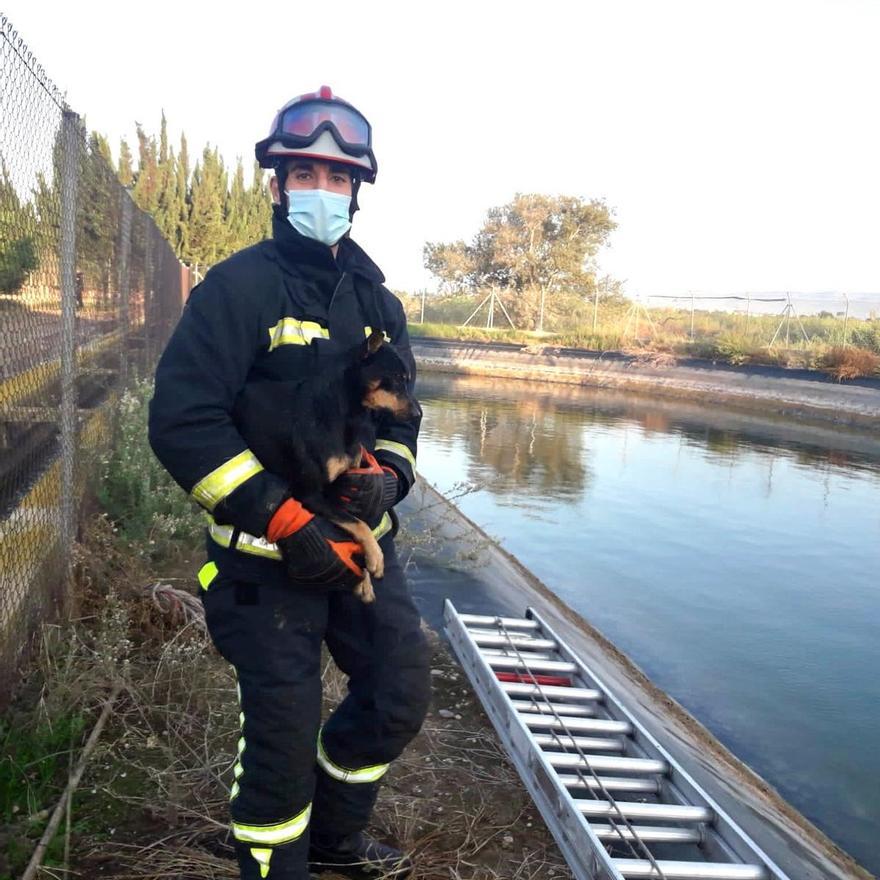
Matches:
[0,0,880,294]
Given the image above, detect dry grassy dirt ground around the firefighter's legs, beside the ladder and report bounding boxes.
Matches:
[0,518,571,880]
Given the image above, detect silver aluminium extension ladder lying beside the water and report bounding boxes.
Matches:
[444,599,788,880]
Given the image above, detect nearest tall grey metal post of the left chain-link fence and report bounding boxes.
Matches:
[59,110,84,592]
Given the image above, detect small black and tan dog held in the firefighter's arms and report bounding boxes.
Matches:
[232,331,421,602]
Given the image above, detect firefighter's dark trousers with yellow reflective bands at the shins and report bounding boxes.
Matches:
[202,535,431,880]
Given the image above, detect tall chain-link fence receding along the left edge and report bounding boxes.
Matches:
[0,16,190,699]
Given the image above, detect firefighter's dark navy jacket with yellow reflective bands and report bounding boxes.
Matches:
[149,207,419,577]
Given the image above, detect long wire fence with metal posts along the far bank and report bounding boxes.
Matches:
[401,288,880,357]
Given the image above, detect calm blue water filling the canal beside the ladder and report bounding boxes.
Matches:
[419,376,880,872]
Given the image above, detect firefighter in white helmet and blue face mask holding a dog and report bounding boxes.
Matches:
[149,86,430,880]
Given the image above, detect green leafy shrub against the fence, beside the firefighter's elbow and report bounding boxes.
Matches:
[97,380,204,552]
